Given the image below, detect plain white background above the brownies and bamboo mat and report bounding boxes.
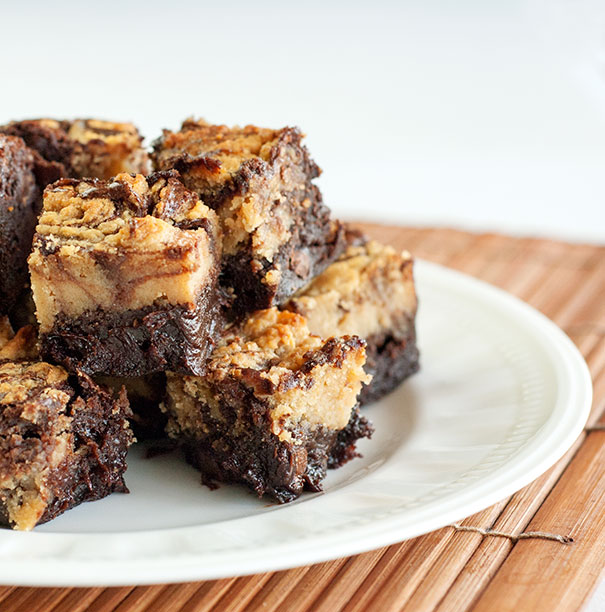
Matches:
[0,0,605,243]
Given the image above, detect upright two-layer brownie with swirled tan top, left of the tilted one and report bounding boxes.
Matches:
[29,171,221,376]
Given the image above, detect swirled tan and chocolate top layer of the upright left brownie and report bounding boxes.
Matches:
[29,171,220,332]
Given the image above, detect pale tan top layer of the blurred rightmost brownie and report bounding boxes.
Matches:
[286,241,417,338]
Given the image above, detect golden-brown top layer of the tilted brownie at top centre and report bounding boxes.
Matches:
[152,119,320,261]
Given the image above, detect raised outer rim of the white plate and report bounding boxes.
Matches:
[0,259,592,586]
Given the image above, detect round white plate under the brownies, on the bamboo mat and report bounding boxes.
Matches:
[0,262,592,586]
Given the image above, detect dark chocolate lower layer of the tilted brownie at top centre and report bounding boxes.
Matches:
[220,185,346,316]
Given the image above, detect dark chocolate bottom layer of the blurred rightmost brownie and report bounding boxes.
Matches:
[359,323,420,406]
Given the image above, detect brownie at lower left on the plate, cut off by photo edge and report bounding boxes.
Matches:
[0,361,133,530]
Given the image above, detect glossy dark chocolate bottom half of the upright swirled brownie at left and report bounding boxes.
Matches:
[40,284,223,376]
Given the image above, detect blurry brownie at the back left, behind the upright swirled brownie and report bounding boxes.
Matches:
[0,119,149,187]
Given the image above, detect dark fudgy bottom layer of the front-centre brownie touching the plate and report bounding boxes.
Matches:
[183,400,373,503]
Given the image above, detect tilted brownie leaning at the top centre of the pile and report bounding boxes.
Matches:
[152,119,344,315]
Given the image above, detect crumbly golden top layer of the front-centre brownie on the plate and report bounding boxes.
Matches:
[169,308,370,440]
